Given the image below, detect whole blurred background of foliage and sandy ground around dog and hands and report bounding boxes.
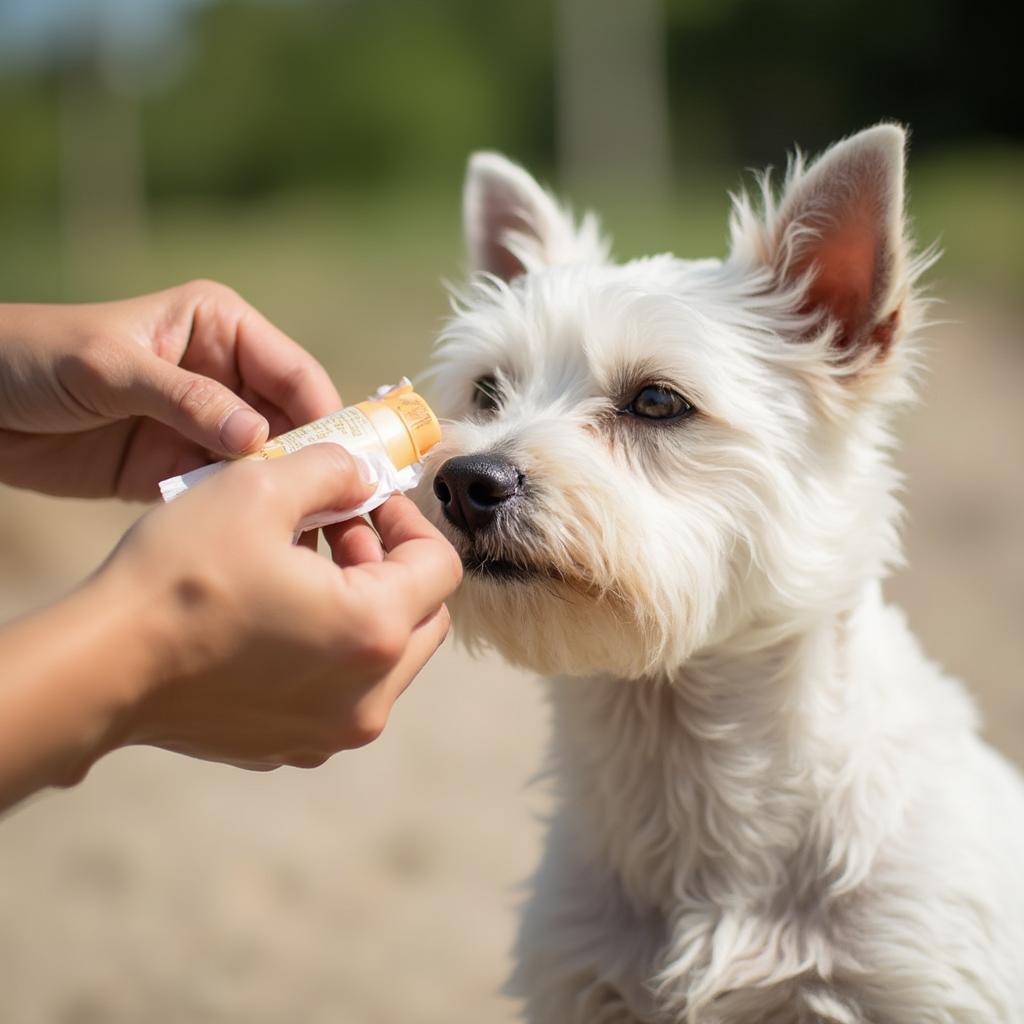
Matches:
[0,0,1024,1024]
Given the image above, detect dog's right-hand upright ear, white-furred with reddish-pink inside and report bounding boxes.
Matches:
[734,125,913,358]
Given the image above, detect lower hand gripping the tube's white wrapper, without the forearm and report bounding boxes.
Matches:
[86,444,462,769]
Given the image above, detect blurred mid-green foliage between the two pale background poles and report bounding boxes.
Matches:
[146,0,551,197]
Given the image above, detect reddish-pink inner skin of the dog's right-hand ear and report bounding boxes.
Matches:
[796,210,880,348]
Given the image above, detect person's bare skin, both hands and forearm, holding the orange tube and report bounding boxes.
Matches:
[0,283,461,808]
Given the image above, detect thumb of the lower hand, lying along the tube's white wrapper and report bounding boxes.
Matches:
[249,441,377,531]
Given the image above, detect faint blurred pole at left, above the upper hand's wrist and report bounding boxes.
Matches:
[59,60,146,297]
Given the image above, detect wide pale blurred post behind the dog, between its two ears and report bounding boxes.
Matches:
[557,0,672,199]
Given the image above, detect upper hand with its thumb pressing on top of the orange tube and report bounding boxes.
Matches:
[0,281,341,500]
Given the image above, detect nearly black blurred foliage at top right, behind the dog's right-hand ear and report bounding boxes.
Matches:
[668,0,1024,166]
